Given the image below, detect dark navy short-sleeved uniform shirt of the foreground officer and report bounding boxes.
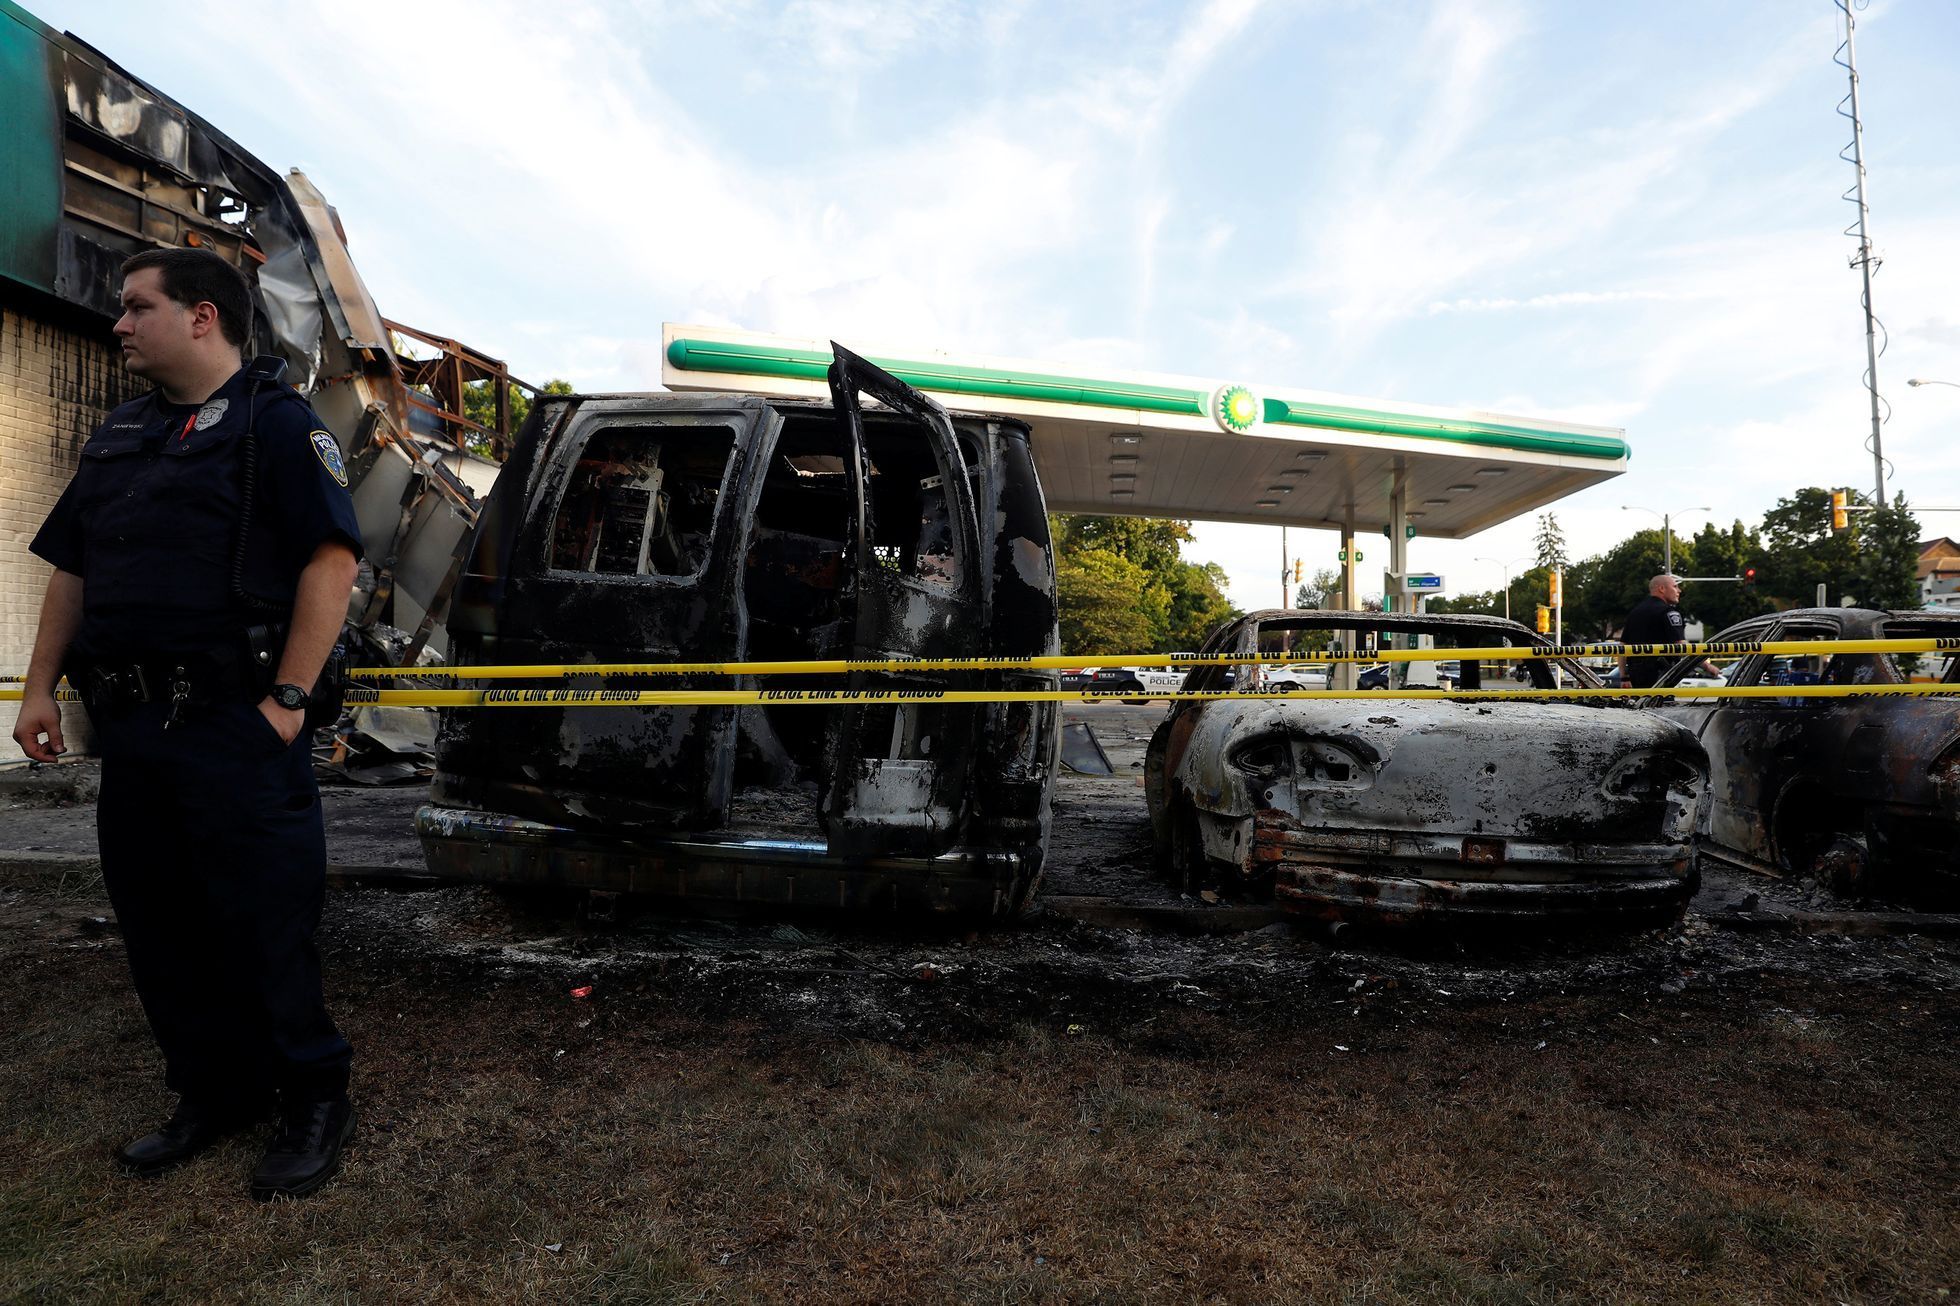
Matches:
[31,369,361,657]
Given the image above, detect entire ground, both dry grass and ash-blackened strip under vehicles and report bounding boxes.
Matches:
[0,704,1960,1302]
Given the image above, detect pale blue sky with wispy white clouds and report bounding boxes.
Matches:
[25,0,1960,606]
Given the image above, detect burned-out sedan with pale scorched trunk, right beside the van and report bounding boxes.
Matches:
[1145,610,1707,926]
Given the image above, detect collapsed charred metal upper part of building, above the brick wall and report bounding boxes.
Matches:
[0,0,521,657]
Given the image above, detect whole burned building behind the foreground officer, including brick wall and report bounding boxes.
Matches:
[0,0,521,698]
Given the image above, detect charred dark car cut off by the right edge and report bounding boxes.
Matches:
[1654,608,1960,906]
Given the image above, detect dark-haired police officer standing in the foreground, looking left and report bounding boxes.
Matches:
[14,249,361,1200]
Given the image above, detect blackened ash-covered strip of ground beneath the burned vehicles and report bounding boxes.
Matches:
[0,704,1960,1045]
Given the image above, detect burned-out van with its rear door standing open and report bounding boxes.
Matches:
[417,349,1058,914]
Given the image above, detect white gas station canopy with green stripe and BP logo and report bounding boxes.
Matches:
[661,324,1629,539]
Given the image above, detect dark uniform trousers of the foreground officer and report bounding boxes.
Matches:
[90,702,353,1112]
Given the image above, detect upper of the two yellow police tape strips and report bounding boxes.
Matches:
[347,637,1960,680]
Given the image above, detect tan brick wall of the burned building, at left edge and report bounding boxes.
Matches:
[0,304,143,757]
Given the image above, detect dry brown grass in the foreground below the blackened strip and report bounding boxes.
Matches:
[0,890,1960,1302]
